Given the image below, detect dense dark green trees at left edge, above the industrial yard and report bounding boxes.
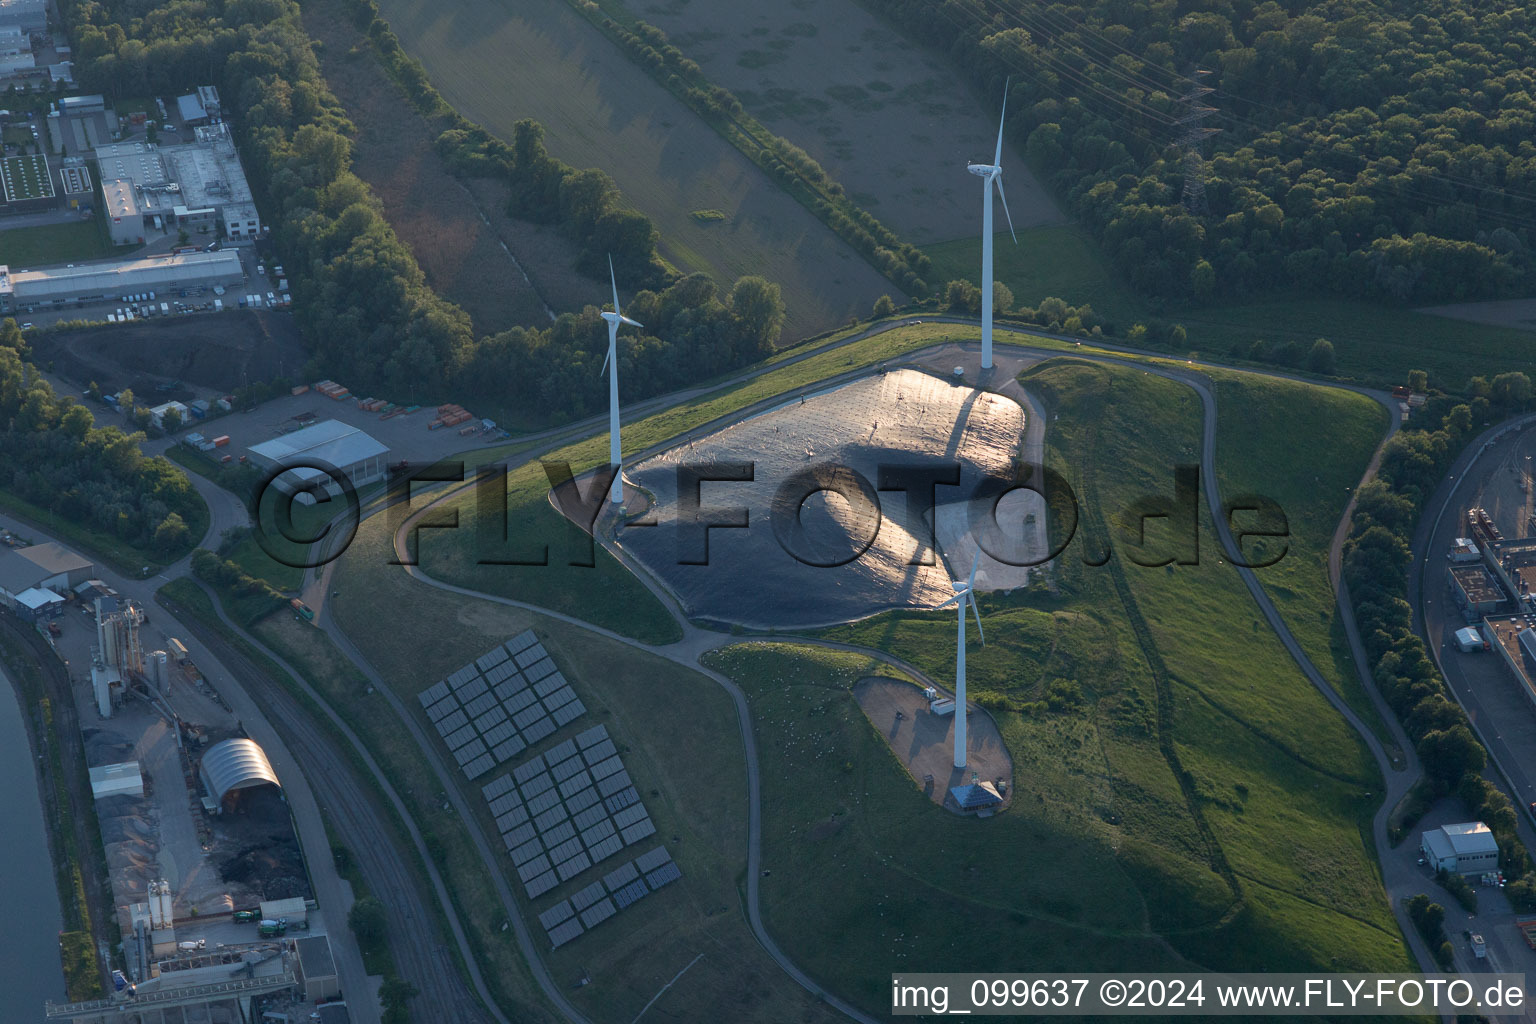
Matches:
[0,319,203,557]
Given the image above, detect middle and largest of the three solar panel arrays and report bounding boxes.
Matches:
[481,725,656,900]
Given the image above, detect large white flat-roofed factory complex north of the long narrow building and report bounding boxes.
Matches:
[95,121,261,238]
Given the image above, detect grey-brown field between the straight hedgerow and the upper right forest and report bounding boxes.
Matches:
[605,0,1063,244]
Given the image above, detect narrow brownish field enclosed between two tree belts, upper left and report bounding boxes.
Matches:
[304,0,580,335]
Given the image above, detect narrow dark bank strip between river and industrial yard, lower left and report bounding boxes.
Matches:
[0,629,106,1003]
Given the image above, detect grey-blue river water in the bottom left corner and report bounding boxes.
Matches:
[0,672,65,1022]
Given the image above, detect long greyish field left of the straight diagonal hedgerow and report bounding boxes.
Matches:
[365,0,902,344]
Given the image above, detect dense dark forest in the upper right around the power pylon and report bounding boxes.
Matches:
[869,0,1536,304]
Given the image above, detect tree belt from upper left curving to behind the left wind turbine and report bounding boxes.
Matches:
[61,0,783,419]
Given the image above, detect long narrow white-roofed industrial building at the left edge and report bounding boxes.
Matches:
[0,252,246,313]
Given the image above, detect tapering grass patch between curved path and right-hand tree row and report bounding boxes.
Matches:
[1206,372,1395,749]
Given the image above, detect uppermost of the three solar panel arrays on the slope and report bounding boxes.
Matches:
[418,629,587,778]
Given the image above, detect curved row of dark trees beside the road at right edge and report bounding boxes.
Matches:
[1344,372,1536,910]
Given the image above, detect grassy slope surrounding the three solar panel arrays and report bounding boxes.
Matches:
[330,517,831,1022]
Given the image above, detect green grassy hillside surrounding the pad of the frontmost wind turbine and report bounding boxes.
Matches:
[752,361,1409,1009]
